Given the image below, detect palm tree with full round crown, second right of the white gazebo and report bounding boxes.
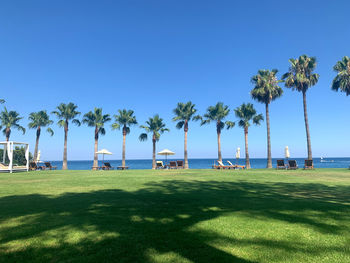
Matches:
[52,102,80,170]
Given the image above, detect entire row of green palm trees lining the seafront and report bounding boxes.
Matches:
[0,55,350,169]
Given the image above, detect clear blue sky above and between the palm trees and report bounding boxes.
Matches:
[0,0,350,160]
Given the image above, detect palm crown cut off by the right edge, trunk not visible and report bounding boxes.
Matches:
[332,56,350,96]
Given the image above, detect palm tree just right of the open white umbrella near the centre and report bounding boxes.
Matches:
[173,101,200,169]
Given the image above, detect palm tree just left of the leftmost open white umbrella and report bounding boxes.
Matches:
[82,108,111,170]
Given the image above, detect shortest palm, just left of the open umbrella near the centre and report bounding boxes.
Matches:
[139,114,170,169]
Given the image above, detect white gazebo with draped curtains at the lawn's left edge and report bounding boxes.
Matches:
[0,141,29,173]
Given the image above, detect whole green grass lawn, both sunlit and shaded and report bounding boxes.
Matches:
[0,169,350,263]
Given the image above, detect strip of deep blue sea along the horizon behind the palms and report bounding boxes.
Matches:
[47,157,350,170]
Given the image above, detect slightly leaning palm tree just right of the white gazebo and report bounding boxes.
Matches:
[28,110,53,160]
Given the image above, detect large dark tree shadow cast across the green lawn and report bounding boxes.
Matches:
[0,181,350,263]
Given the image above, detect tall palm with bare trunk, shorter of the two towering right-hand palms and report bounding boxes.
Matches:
[250,69,283,168]
